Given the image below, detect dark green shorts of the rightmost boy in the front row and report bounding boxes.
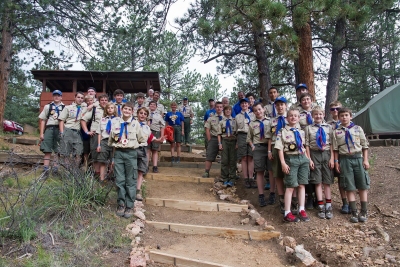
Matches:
[339,154,371,191]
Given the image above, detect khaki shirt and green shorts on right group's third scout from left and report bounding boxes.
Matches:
[235,111,255,159]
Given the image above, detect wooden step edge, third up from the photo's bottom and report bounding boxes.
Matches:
[145,198,248,212]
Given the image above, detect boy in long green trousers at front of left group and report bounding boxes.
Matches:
[108,102,147,218]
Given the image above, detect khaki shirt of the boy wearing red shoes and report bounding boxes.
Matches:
[275,125,306,155]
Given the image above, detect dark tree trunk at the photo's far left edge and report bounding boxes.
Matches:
[0,10,13,125]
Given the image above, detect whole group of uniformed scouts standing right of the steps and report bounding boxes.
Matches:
[203,84,370,223]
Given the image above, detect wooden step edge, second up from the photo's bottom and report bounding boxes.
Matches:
[146,221,281,240]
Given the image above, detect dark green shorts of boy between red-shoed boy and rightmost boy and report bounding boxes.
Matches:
[309,150,334,184]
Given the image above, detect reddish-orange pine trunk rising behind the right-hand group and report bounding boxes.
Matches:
[296,20,315,99]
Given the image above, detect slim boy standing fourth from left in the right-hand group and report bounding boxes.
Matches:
[246,102,269,207]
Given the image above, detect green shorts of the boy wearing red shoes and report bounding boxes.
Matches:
[283,154,310,188]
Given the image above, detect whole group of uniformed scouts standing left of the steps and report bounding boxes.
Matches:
[39,87,181,218]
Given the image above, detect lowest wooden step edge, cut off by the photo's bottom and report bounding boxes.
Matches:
[149,250,230,267]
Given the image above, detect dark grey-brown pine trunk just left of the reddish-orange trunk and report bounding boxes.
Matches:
[254,30,271,104]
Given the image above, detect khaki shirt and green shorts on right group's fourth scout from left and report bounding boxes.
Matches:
[246,118,269,172]
